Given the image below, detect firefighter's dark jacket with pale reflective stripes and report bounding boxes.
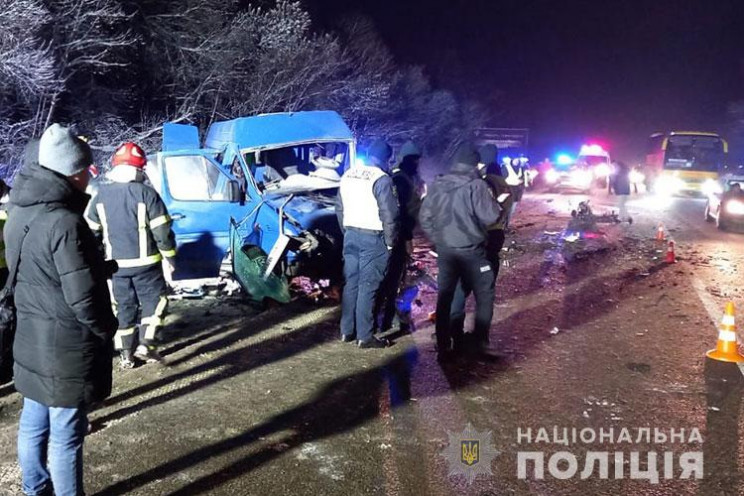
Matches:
[87,181,176,273]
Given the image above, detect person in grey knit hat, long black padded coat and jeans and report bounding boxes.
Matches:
[5,124,117,495]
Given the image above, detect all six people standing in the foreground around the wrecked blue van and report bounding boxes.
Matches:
[0,124,513,496]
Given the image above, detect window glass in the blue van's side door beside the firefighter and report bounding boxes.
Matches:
[165,155,229,201]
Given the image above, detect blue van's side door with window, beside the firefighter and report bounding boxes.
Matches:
[159,152,247,279]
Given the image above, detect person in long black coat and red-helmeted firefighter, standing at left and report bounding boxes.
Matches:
[4,124,176,496]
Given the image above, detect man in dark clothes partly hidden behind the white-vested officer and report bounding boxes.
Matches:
[379,141,424,331]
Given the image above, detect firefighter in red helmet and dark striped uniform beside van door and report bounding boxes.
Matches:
[88,143,176,368]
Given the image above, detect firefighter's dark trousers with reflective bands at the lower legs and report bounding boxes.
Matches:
[111,263,168,350]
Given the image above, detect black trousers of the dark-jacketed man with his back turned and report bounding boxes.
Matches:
[436,247,496,353]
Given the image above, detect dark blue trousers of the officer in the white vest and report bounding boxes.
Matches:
[341,229,390,341]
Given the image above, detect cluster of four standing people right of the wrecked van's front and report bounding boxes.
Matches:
[337,140,515,362]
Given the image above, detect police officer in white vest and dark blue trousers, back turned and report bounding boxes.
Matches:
[336,140,399,348]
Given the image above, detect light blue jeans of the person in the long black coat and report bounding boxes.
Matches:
[18,398,88,496]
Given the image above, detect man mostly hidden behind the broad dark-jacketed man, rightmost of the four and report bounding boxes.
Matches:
[450,145,514,352]
